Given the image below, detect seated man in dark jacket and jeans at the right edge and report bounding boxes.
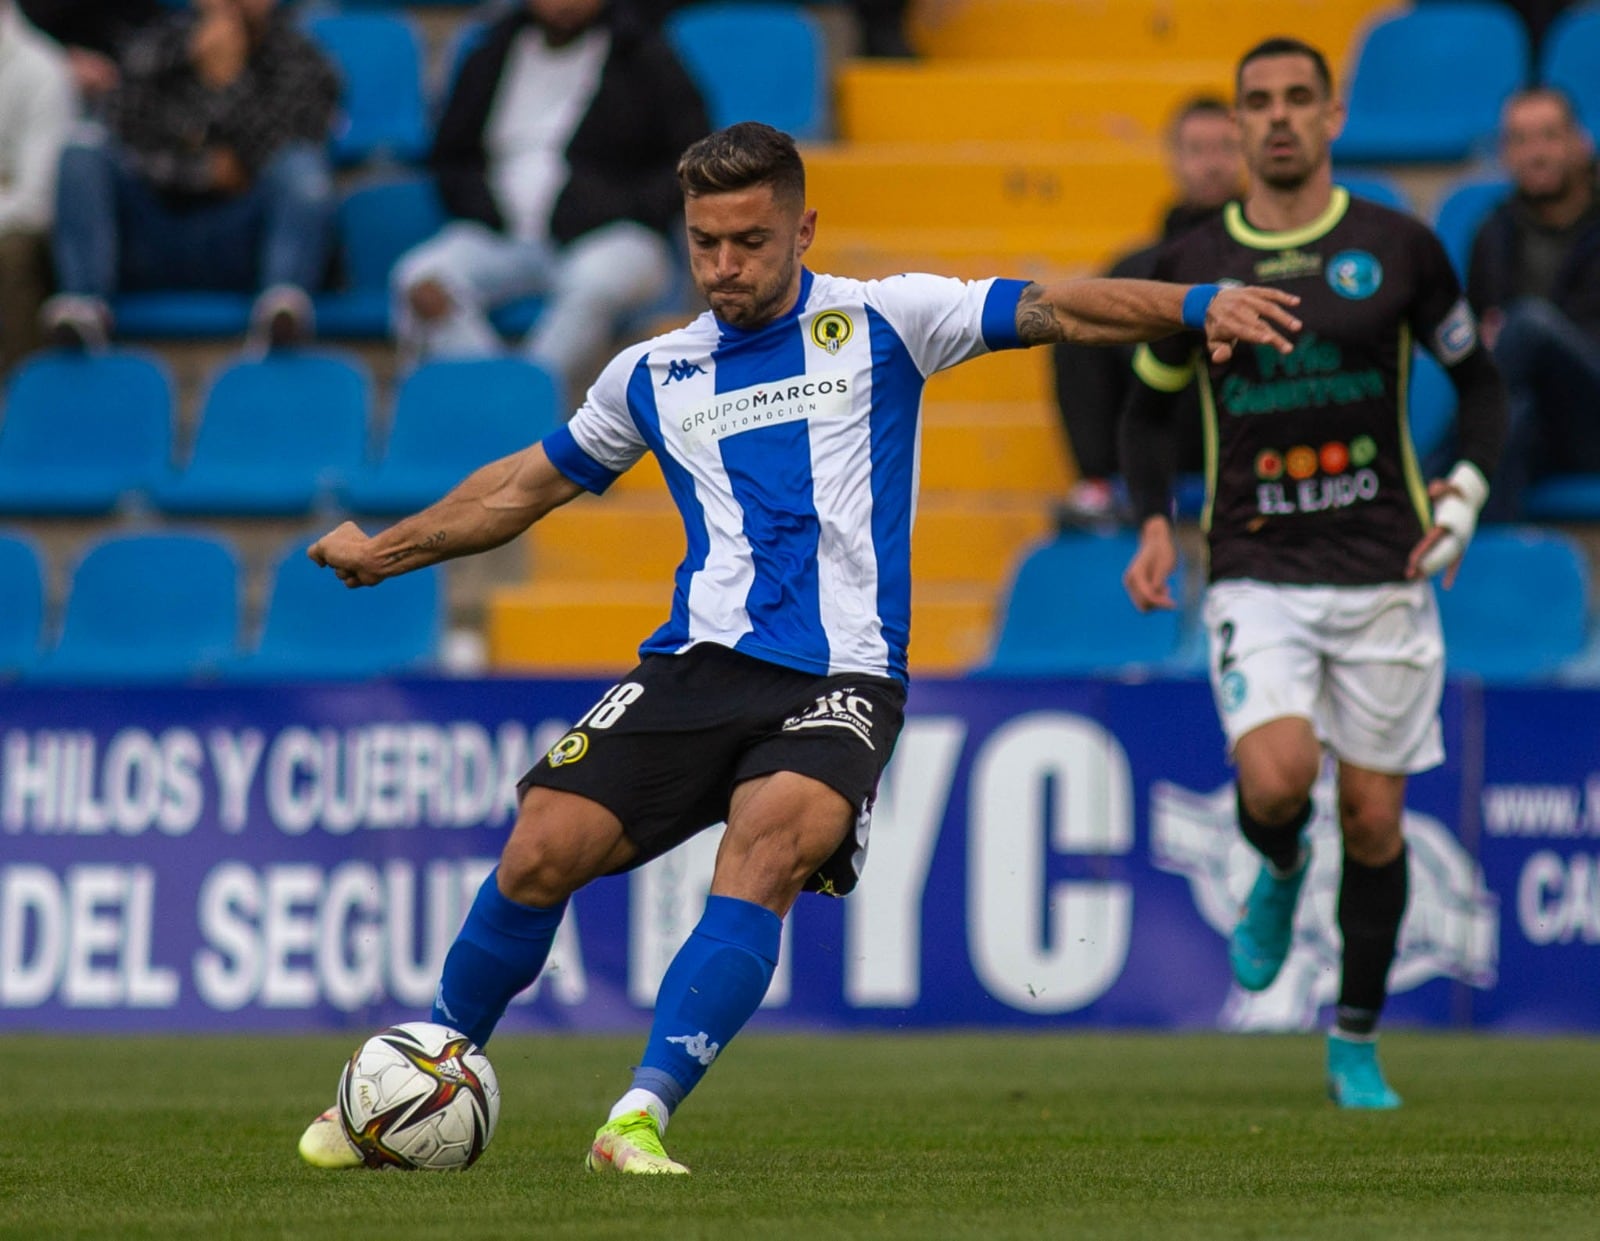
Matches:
[1467,86,1600,520]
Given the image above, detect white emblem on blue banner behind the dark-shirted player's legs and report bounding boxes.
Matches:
[1150,776,1499,1030]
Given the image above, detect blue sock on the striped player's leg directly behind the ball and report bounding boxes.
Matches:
[430,872,566,1047]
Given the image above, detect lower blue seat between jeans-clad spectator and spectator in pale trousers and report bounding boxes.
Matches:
[315,176,446,337]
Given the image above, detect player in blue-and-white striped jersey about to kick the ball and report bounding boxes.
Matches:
[301,123,1299,1174]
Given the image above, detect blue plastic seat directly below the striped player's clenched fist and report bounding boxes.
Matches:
[227,541,443,681]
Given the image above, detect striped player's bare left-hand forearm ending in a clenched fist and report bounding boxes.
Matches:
[306,445,582,587]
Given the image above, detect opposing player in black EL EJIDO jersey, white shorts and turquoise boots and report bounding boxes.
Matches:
[1123,38,1506,1108]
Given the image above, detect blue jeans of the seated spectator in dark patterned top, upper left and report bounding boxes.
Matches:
[54,138,334,299]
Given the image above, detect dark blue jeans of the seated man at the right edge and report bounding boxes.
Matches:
[1485,297,1600,521]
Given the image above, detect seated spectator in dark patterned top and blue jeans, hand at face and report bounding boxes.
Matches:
[45,0,339,347]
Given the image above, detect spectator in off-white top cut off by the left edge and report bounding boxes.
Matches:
[0,0,77,374]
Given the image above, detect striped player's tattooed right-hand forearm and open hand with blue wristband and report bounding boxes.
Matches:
[1016,277,1301,363]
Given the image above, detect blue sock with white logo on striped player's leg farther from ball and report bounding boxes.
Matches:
[634,896,784,1113]
